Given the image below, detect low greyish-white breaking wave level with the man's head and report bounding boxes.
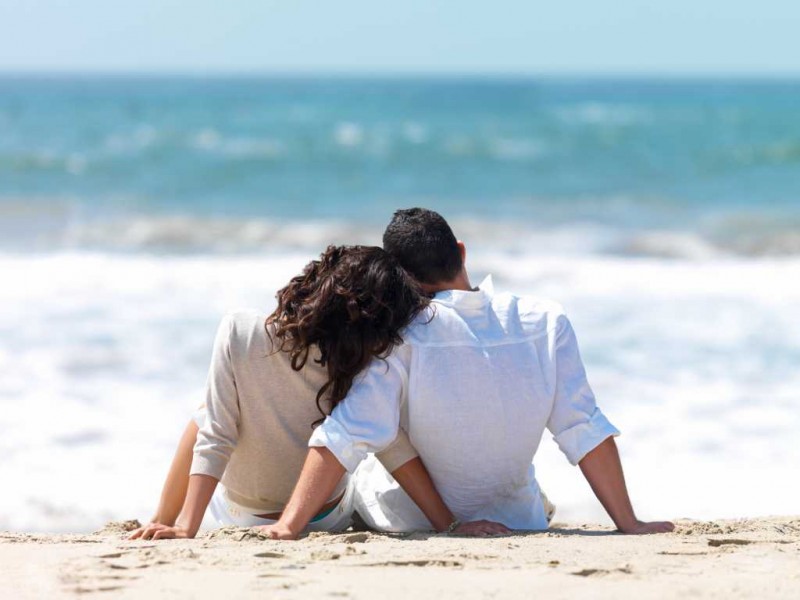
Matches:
[63,216,800,261]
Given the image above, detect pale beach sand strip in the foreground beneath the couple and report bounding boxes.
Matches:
[0,516,800,600]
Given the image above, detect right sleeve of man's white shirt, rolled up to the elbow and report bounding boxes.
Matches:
[547,315,619,465]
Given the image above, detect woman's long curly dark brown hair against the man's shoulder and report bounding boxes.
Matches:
[266,246,428,425]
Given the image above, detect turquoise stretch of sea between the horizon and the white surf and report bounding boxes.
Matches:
[0,77,800,254]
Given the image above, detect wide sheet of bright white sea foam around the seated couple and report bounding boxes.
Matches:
[0,249,800,531]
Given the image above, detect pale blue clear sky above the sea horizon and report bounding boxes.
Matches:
[0,0,800,77]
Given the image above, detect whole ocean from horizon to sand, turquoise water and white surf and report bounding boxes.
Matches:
[0,75,800,531]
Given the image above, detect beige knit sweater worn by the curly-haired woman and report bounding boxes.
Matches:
[191,311,417,513]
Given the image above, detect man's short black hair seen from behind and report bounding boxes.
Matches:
[383,208,462,285]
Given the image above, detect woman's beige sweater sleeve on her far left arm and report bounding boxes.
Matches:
[190,316,240,479]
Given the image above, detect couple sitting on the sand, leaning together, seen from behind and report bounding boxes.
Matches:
[131,208,672,539]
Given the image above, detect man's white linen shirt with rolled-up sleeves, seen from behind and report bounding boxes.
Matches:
[309,277,619,530]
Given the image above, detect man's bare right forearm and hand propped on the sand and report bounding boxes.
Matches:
[578,437,675,534]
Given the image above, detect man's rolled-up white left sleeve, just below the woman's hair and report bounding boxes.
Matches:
[308,347,413,473]
